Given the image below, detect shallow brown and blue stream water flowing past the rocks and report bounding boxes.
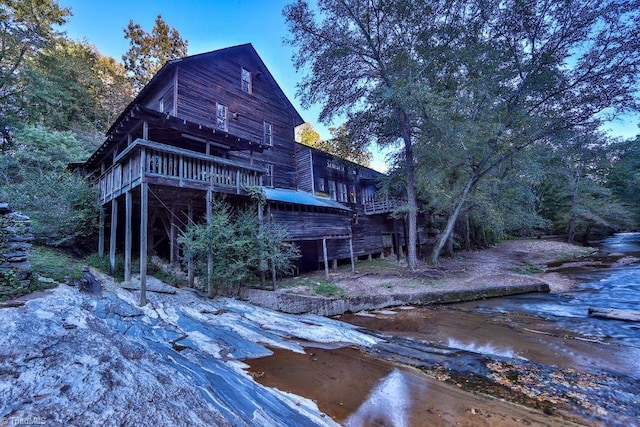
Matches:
[249,233,640,426]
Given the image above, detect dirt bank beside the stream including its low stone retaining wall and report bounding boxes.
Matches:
[244,239,594,315]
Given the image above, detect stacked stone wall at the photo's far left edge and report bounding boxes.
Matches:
[0,202,33,299]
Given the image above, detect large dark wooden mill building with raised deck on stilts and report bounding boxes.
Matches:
[84,44,404,296]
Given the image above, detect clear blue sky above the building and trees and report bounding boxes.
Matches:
[58,0,640,170]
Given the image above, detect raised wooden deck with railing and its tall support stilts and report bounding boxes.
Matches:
[97,139,264,305]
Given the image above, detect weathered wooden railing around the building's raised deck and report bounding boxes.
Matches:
[97,139,266,203]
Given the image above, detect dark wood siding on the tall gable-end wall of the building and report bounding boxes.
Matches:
[178,51,296,188]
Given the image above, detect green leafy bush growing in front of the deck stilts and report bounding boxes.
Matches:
[178,199,299,296]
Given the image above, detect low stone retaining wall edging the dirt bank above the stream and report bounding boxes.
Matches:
[242,282,549,316]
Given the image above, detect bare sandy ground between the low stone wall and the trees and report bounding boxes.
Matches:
[281,239,595,297]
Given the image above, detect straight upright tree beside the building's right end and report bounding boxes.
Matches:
[283,0,444,269]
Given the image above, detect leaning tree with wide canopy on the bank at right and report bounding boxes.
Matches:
[422,0,640,262]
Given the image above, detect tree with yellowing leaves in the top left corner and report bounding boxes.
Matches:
[0,0,71,142]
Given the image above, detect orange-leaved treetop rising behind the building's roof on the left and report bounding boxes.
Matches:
[122,15,189,90]
